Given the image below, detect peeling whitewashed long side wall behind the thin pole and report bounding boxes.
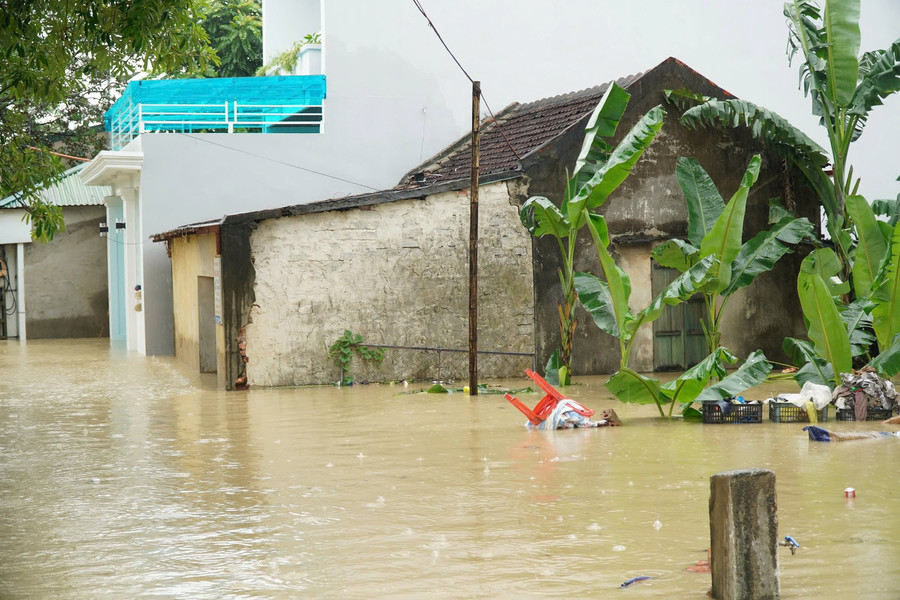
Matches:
[246,182,534,386]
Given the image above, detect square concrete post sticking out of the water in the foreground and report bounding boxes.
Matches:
[709,469,779,600]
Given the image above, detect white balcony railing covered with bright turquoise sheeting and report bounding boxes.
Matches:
[105,75,325,150]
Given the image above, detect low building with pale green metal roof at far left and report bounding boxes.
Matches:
[0,164,110,341]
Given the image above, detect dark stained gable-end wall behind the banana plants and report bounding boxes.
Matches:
[519,63,818,375]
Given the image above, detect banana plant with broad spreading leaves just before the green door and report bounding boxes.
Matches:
[651,155,813,354]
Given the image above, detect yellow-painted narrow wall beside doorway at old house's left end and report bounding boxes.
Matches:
[168,233,224,371]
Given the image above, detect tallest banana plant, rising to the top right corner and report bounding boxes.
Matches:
[680,0,900,284]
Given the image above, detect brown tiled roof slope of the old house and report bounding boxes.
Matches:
[395,73,643,189]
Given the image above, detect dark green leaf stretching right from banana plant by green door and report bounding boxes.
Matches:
[722,216,813,296]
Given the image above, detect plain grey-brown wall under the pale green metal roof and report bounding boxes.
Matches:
[25,206,109,339]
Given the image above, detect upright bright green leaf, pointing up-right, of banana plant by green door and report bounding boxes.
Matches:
[700,154,762,292]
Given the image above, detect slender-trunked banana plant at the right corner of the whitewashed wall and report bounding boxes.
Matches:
[519,82,665,385]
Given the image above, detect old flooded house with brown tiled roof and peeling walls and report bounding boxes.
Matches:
[153,58,816,389]
